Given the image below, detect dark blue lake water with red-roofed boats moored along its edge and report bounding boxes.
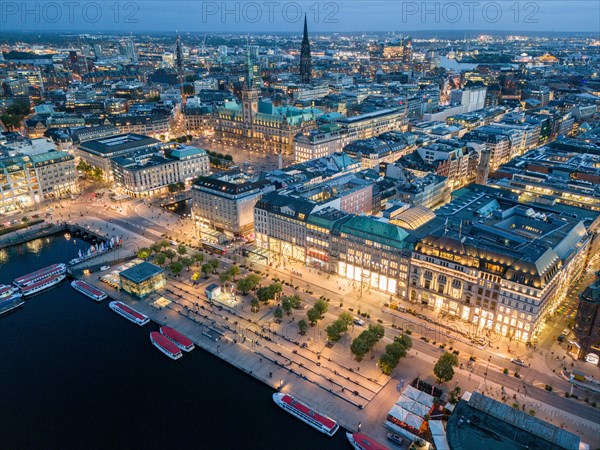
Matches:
[0,236,349,450]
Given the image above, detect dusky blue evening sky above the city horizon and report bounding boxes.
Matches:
[0,0,600,32]
